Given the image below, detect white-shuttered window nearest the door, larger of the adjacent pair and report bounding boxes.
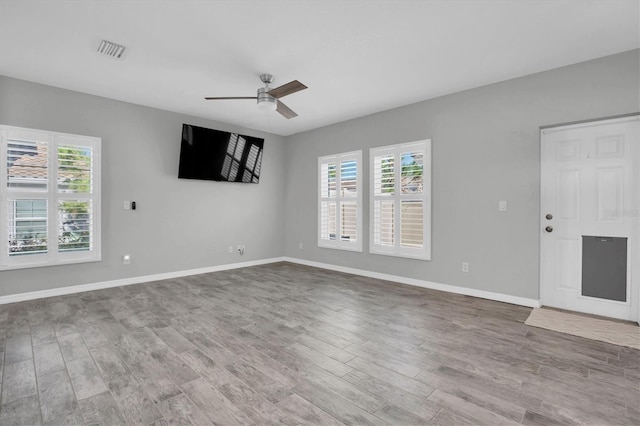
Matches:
[369,139,431,260]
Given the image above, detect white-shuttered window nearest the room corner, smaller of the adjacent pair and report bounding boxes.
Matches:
[318,151,362,251]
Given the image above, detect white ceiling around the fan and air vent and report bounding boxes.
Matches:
[0,0,640,135]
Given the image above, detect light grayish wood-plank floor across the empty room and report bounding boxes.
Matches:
[0,263,640,425]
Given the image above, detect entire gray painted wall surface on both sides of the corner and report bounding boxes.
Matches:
[0,50,640,299]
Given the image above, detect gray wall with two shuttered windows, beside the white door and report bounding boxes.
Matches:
[285,50,640,299]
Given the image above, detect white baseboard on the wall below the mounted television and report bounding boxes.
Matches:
[0,257,284,305]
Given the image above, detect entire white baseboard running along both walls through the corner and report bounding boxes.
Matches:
[0,257,540,308]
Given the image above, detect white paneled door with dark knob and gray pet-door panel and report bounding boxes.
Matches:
[540,116,640,321]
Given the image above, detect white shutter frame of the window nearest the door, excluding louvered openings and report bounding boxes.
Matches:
[369,139,432,260]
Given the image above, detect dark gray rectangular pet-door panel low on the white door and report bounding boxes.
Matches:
[582,235,627,302]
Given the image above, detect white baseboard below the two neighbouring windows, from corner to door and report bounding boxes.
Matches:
[284,257,540,308]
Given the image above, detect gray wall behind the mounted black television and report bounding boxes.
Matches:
[0,76,285,296]
